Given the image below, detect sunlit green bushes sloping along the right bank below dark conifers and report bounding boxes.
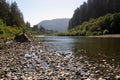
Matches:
[59,13,120,36]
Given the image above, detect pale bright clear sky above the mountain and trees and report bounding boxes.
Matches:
[7,0,87,26]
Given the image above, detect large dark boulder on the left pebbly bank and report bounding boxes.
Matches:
[14,33,30,42]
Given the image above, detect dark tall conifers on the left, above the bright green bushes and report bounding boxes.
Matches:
[0,0,25,27]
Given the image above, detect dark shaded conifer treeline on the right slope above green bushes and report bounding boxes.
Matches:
[68,0,120,29]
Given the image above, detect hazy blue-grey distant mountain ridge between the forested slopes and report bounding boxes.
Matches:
[37,18,69,32]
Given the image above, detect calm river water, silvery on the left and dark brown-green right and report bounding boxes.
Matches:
[40,36,120,62]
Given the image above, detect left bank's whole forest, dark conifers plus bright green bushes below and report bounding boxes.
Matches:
[0,0,30,38]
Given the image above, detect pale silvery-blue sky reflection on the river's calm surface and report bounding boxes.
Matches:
[42,37,75,53]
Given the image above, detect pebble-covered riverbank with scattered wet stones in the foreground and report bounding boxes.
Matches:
[0,38,120,80]
